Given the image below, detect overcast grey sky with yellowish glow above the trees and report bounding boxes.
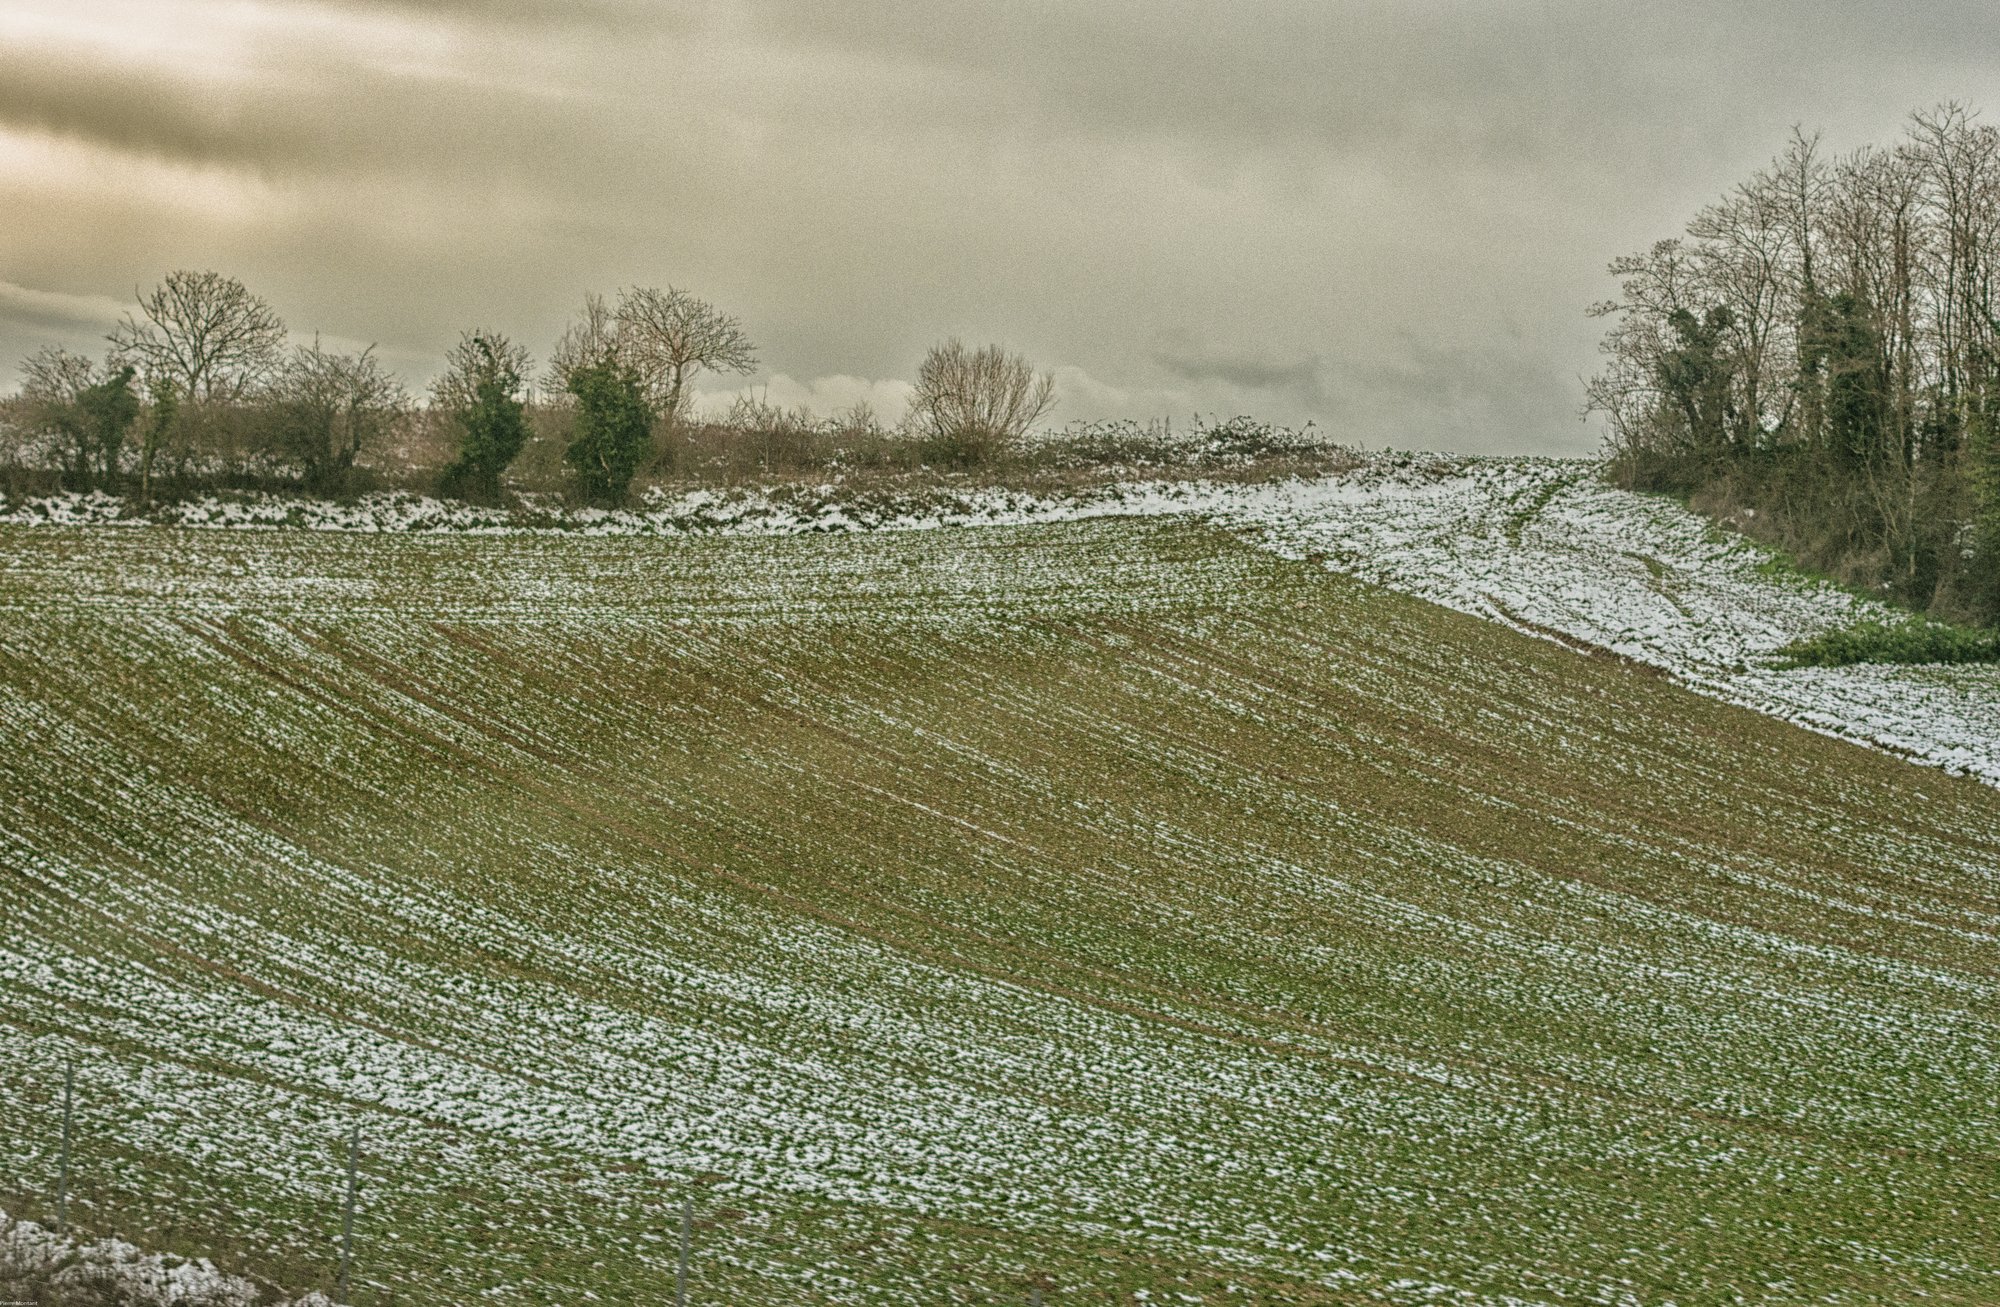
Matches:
[0,0,2000,452]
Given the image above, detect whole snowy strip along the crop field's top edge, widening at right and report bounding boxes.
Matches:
[0,456,2000,785]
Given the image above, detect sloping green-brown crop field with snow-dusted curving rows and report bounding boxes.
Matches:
[0,520,2000,1307]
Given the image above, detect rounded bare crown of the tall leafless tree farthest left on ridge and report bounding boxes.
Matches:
[110,270,284,402]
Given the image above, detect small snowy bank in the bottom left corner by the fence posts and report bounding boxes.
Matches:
[0,1211,334,1307]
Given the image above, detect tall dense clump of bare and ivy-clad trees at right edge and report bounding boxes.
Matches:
[1588,104,2000,622]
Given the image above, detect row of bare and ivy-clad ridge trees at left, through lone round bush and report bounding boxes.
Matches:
[0,270,1054,506]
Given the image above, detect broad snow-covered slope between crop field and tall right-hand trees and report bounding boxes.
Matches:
[1218,460,2000,783]
